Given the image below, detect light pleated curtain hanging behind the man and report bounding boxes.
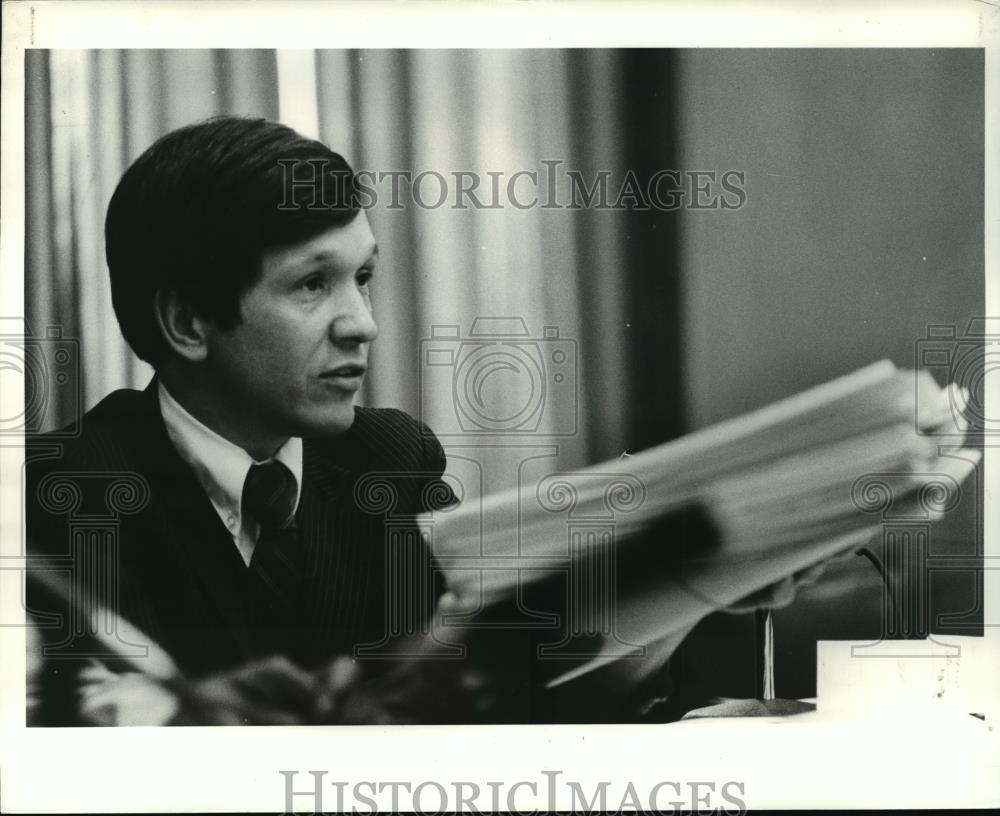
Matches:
[25,50,653,467]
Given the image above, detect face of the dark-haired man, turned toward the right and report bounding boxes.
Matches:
[207,211,378,441]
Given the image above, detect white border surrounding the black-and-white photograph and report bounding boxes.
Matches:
[0,0,1000,812]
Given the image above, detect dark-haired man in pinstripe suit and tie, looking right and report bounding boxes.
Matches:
[27,118,458,728]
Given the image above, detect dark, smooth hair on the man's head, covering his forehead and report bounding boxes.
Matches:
[104,116,359,366]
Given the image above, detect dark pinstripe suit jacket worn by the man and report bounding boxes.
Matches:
[26,380,454,676]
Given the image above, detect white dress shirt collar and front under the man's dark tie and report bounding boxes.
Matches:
[159,382,302,566]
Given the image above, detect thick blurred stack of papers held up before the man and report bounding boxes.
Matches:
[433,361,978,680]
